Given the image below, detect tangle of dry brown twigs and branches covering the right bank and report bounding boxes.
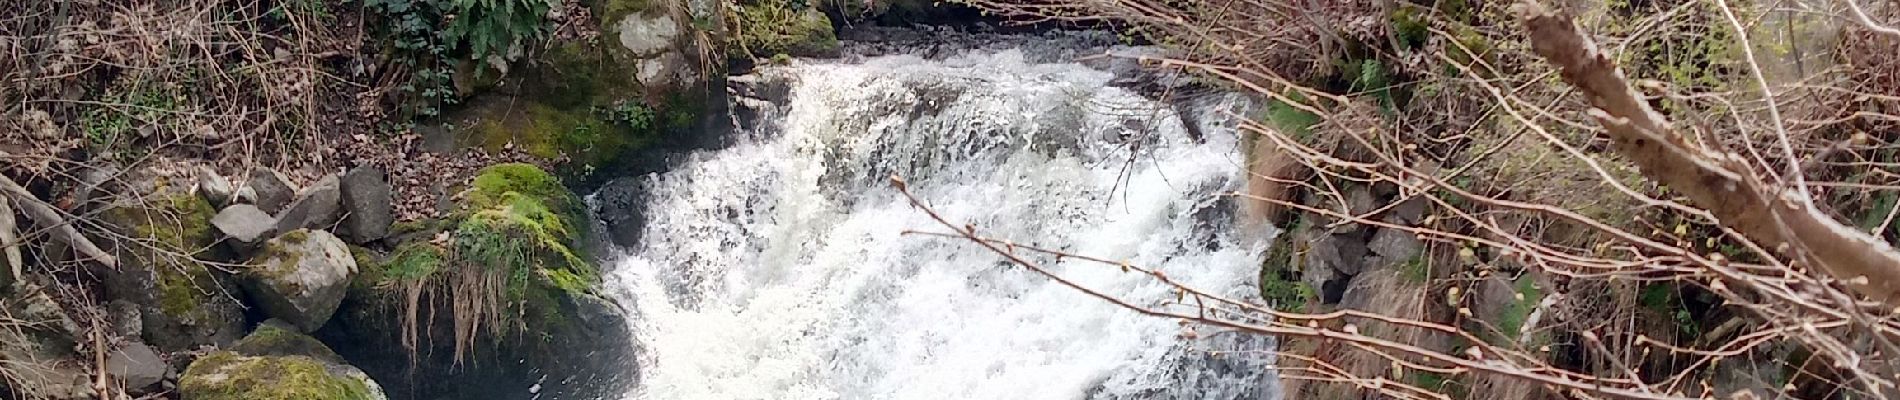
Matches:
[899,0,1900,398]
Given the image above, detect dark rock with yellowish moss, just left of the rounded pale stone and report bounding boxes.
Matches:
[101,190,243,351]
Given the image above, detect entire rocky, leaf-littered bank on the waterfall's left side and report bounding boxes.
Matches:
[0,0,1048,400]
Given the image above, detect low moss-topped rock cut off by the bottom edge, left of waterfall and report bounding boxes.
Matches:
[179,351,386,400]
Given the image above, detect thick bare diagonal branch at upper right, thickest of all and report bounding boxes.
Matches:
[1520,2,1900,305]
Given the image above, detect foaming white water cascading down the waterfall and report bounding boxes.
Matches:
[610,41,1277,400]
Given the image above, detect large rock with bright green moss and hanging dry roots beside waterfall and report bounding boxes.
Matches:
[327,163,633,398]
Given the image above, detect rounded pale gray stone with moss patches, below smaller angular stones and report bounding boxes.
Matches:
[241,229,357,332]
